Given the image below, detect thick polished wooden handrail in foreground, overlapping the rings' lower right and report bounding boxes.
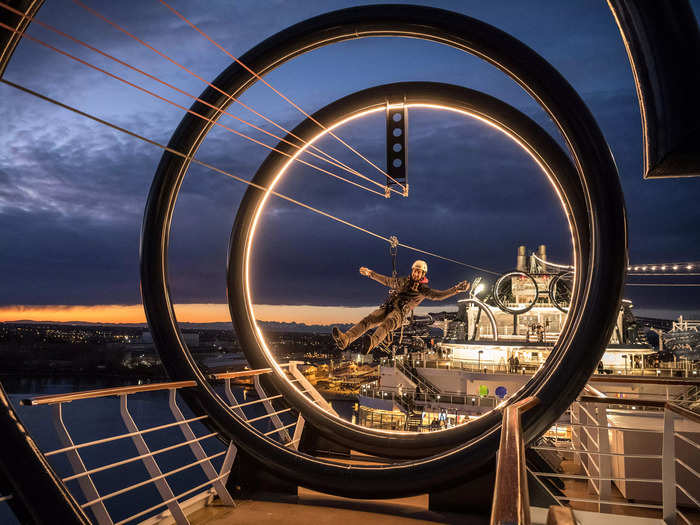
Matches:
[491,396,540,525]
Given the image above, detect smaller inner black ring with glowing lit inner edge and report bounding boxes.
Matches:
[228,82,576,457]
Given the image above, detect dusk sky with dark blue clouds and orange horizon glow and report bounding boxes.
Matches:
[0,0,700,324]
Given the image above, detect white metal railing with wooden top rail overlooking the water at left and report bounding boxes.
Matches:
[21,369,303,525]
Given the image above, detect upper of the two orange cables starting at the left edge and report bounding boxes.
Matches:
[0,0,396,195]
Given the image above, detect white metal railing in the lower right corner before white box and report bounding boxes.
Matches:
[528,396,700,523]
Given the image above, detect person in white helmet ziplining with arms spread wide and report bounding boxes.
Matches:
[333,260,469,352]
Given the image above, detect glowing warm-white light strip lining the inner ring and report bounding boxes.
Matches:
[245,102,578,435]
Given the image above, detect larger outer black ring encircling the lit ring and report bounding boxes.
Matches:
[141,5,627,498]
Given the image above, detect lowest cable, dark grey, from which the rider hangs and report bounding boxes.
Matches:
[0,77,499,275]
